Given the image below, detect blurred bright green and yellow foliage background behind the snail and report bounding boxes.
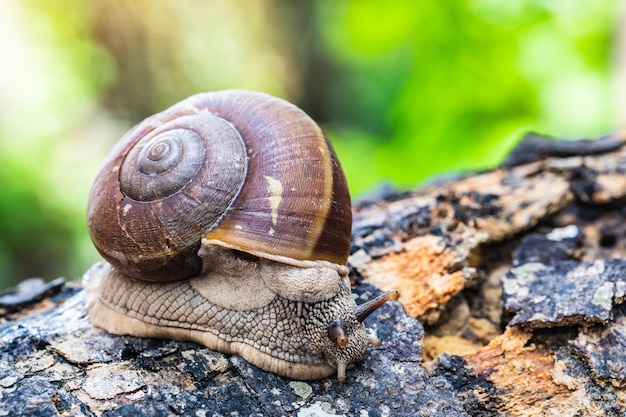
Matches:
[0,0,626,288]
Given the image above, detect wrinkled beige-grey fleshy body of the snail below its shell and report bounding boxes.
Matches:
[84,249,369,380]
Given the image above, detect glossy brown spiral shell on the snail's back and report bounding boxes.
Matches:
[87,90,352,281]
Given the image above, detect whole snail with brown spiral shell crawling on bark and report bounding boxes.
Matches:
[85,90,398,382]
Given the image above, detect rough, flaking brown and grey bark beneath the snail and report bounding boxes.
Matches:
[0,131,626,417]
